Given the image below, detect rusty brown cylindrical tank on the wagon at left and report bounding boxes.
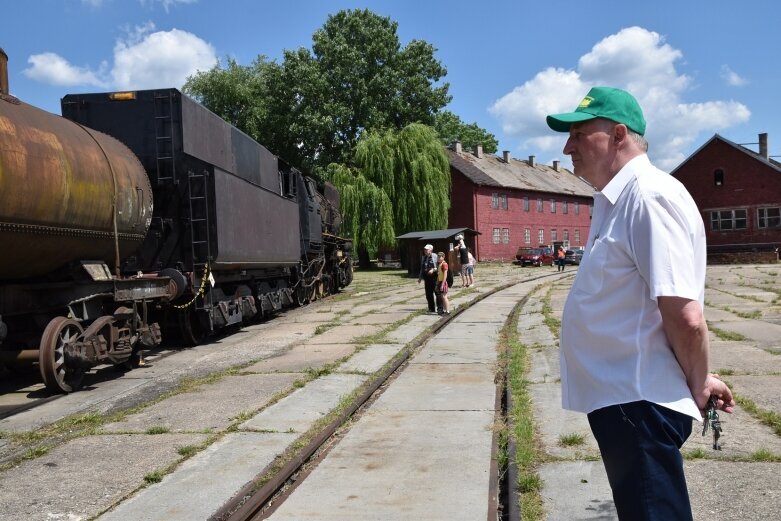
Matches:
[0,74,152,280]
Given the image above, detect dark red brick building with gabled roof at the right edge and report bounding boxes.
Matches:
[671,134,781,254]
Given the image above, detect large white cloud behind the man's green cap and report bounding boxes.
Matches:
[489,27,751,170]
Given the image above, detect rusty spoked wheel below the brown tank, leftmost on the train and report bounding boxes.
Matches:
[38,317,84,393]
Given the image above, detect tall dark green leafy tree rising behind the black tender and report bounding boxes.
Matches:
[184,9,450,171]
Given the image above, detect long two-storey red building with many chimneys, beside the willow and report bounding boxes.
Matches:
[447,143,594,261]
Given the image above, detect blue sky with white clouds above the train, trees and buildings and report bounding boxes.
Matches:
[6,0,781,170]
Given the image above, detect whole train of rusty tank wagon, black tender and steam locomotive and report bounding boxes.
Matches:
[0,51,352,392]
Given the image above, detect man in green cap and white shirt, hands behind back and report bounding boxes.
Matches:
[547,87,735,521]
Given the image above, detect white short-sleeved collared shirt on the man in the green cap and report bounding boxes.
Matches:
[560,155,706,420]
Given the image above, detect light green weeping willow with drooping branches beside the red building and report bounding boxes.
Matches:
[328,123,450,266]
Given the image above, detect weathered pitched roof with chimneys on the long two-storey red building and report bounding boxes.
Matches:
[446,149,594,197]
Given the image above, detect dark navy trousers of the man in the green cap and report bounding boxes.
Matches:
[588,401,692,521]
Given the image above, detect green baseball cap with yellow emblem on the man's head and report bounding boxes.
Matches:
[546,87,645,136]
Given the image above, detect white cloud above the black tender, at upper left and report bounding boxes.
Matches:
[24,22,217,90]
